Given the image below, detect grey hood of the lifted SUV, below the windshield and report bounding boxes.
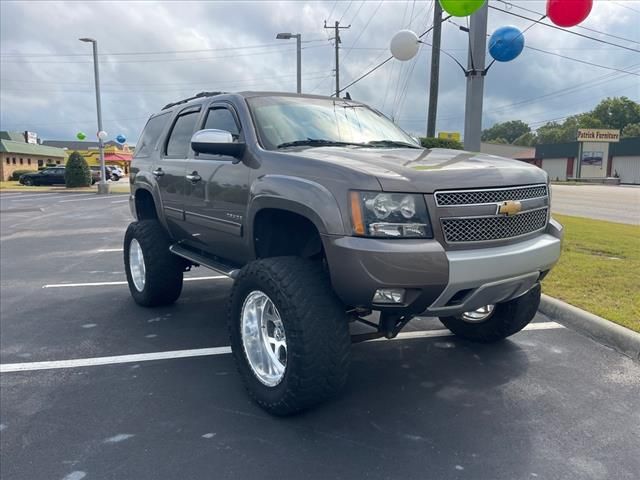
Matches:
[291,147,547,193]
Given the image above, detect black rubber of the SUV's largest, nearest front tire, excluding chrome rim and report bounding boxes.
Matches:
[228,257,351,416]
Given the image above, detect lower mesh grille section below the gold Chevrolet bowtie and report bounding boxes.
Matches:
[440,208,547,243]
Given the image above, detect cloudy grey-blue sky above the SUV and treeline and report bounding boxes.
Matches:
[0,0,640,143]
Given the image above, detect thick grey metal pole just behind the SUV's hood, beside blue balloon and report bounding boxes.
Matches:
[464,2,489,152]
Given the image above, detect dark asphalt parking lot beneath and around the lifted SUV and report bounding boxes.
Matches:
[0,192,640,480]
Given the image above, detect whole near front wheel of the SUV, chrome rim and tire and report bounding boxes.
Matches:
[229,257,351,415]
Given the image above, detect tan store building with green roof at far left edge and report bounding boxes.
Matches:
[0,131,66,181]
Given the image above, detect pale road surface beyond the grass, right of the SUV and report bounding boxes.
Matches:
[551,185,640,225]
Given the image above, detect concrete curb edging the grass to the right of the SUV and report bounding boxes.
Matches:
[540,294,640,362]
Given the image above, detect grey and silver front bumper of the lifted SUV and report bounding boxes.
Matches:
[323,220,562,316]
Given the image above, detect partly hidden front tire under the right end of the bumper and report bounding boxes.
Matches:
[440,283,540,343]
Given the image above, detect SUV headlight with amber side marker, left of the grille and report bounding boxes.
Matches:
[350,192,433,238]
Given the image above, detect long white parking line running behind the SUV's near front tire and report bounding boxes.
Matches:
[0,322,564,373]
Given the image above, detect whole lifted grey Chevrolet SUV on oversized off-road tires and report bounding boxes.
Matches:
[124,92,562,415]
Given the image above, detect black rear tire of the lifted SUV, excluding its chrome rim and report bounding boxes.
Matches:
[124,220,184,307]
